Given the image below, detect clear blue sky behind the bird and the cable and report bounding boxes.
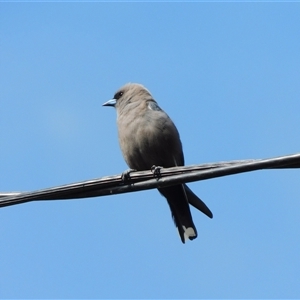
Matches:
[0,2,300,298]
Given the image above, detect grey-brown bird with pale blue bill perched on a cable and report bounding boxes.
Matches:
[103,83,213,243]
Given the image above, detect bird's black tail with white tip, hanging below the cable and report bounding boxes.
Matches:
[158,184,201,243]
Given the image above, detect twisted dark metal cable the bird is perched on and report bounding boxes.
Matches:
[0,153,300,207]
